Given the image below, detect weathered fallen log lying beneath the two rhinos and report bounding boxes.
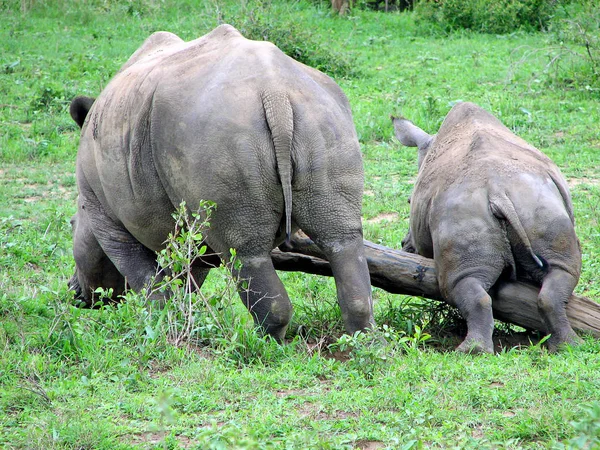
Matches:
[271,234,600,337]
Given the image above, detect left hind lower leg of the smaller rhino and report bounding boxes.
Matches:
[451,277,494,353]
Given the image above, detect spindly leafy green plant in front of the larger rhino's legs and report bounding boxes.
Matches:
[150,202,282,364]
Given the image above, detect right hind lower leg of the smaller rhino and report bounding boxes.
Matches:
[538,268,580,351]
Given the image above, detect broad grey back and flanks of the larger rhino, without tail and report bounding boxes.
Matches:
[78,25,362,253]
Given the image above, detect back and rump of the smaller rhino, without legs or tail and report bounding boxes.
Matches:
[411,104,579,282]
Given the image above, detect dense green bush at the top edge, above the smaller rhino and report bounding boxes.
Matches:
[415,0,557,34]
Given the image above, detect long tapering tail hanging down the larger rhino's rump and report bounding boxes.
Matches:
[261,91,294,242]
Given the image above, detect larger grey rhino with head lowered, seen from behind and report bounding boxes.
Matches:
[70,25,374,341]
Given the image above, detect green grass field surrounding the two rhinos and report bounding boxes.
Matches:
[0,0,600,449]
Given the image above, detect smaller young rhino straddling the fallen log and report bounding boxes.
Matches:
[392,103,581,353]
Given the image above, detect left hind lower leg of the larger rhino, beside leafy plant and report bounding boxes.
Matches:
[233,255,293,343]
